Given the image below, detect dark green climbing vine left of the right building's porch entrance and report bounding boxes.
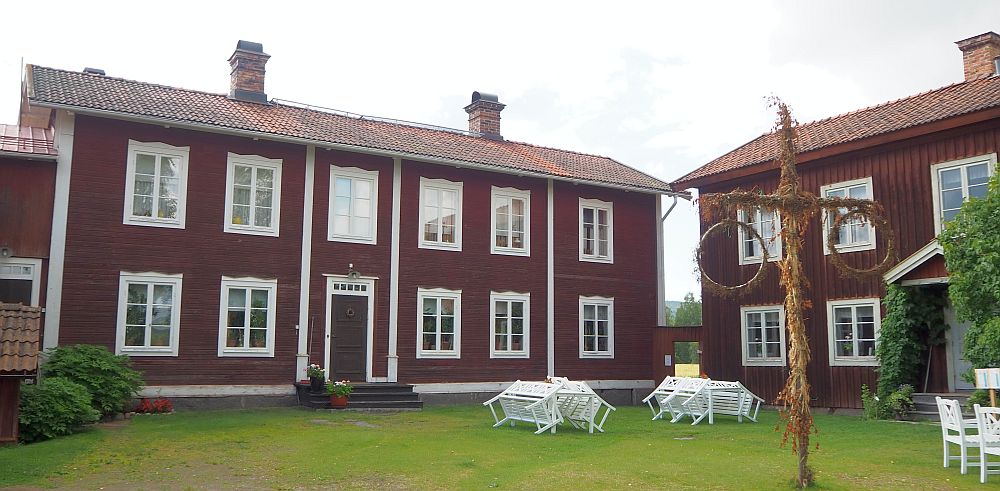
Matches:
[875,285,948,399]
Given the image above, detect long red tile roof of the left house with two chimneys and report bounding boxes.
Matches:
[28,65,671,192]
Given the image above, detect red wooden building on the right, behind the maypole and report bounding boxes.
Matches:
[672,32,1000,408]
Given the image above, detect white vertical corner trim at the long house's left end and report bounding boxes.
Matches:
[42,110,76,349]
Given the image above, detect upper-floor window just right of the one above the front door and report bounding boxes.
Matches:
[418,177,462,251]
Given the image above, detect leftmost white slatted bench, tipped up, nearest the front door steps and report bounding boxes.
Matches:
[483,380,563,435]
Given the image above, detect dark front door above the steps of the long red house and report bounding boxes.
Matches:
[328,295,368,382]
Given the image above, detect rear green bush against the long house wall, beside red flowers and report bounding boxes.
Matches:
[42,344,143,416]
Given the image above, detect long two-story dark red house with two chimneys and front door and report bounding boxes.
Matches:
[7,41,680,408]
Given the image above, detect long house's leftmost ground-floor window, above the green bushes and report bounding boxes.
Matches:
[116,272,182,356]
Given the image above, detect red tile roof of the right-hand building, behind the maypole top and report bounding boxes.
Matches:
[672,77,1000,189]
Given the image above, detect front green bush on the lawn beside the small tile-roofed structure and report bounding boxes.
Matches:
[18,377,101,443]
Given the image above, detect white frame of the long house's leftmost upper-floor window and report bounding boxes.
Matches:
[122,140,191,229]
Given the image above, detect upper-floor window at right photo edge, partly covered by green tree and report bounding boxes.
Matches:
[931,153,997,230]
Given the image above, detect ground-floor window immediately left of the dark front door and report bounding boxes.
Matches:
[219,276,278,357]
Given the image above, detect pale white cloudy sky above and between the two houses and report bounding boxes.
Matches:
[0,0,1000,300]
